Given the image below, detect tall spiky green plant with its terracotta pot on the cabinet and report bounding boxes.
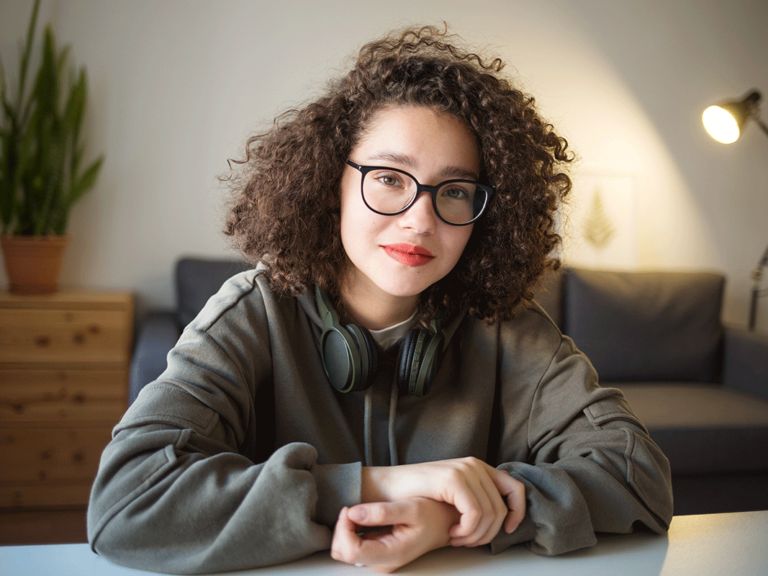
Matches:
[0,0,104,294]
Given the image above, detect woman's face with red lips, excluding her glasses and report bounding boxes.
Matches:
[341,106,480,320]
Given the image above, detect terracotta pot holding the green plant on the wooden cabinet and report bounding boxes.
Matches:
[0,235,69,294]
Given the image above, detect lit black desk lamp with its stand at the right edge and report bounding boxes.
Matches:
[701,90,768,331]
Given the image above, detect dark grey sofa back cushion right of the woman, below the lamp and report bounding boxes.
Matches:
[563,268,725,382]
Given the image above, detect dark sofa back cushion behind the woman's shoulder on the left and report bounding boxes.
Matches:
[176,258,253,328]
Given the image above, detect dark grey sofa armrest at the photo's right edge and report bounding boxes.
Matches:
[723,326,768,400]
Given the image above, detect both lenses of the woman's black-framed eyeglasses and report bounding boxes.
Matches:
[363,169,488,224]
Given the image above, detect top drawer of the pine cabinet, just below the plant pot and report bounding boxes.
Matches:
[0,308,133,364]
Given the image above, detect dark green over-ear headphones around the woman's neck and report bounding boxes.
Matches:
[315,286,445,397]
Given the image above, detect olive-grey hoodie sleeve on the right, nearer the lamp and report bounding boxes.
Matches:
[491,312,672,555]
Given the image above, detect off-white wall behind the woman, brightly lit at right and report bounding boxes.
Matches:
[0,0,768,330]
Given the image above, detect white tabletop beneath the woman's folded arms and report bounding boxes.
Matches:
[0,511,768,576]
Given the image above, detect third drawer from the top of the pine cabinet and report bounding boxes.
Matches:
[0,426,112,489]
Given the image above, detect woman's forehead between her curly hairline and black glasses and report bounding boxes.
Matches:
[352,106,480,174]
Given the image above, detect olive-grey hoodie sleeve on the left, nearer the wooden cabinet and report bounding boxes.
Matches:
[88,276,360,574]
